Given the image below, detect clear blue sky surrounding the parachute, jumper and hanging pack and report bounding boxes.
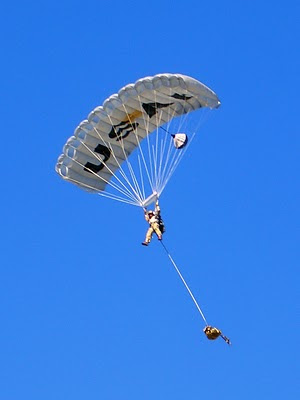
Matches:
[0,0,300,400]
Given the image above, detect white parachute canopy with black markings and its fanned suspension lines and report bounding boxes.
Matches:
[56,74,220,207]
